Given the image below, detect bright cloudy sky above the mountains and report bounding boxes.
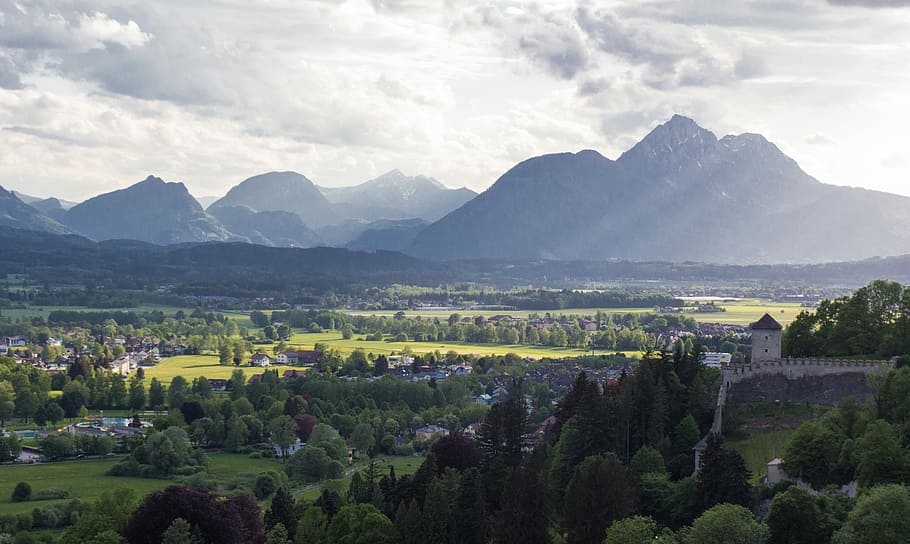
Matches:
[0,0,910,200]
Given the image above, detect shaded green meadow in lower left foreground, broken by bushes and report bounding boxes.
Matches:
[0,453,288,514]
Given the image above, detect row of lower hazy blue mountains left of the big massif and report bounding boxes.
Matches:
[0,170,476,250]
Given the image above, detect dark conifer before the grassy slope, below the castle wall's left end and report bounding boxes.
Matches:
[696,433,751,509]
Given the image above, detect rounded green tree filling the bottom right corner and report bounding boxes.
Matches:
[831,484,910,544]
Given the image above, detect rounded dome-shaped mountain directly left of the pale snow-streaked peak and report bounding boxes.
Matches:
[209,172,340,228]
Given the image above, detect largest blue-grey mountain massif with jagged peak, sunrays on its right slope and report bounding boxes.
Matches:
[408,116,910,263]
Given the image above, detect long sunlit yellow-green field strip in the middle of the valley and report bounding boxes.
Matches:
[289,331,637,359]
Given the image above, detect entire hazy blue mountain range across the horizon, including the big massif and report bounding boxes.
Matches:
[0,115,910,264]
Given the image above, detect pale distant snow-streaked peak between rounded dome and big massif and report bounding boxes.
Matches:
[319,170,477,221]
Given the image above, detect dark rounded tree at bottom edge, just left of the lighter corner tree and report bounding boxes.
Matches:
[765,486,831,544]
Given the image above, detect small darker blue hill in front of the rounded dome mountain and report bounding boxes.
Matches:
[211,206,320,247]
